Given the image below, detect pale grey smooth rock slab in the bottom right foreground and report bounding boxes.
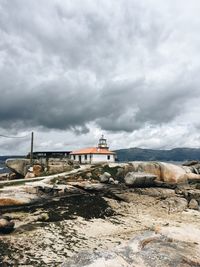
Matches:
[61,227,200,267]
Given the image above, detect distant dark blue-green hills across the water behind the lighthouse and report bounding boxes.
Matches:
[115,147,200,161]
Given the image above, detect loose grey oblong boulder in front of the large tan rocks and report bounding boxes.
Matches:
[124,172,157,187]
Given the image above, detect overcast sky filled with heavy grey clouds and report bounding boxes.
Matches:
[0,0,200,155]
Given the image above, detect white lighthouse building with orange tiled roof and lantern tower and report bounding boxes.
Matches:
[70,135,116,163]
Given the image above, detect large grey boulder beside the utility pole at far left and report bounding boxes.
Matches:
[6,158,30,176]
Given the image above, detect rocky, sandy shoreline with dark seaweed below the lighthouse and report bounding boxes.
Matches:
[0,162,200,267]
